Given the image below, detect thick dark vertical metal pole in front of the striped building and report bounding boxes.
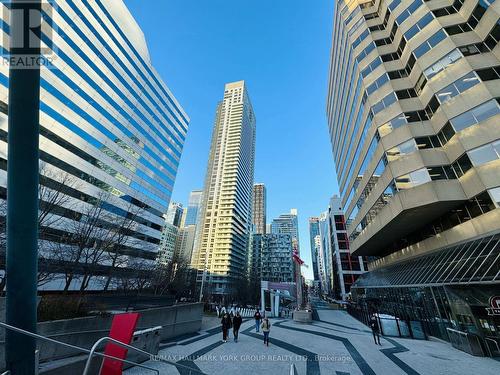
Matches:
[5,0,41,375]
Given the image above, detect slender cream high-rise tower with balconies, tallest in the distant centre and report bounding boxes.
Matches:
[192,81,256,295]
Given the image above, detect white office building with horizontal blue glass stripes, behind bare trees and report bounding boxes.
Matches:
[0,0,189,289]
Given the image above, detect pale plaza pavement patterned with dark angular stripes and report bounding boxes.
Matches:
[125,309,500,375]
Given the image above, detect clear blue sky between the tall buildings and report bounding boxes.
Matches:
[125,0,338,277]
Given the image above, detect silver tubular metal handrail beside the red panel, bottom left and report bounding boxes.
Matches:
[0,322,207,375]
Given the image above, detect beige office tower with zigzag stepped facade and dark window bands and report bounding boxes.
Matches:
[327,0,500,339]
